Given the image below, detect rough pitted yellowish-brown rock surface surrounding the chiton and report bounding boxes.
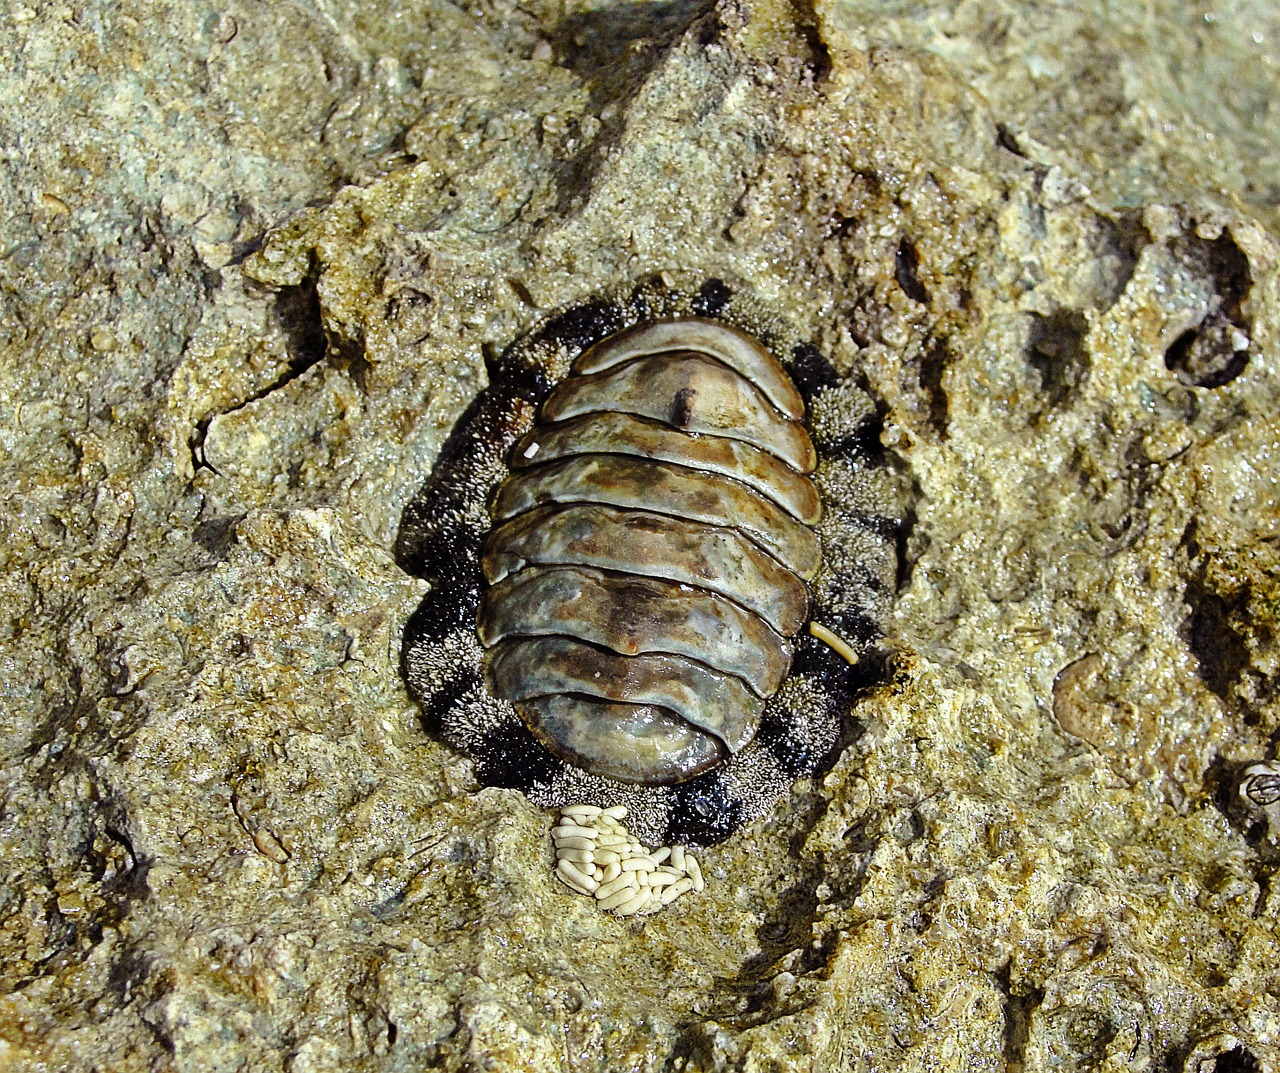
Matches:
[0,0,1280,1073]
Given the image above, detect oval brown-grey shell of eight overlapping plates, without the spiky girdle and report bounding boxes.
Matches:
[480,319,820,785]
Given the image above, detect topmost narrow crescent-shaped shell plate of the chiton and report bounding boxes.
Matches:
[573,318,804,421]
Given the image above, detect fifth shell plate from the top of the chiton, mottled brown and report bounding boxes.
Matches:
[481,503,809,636]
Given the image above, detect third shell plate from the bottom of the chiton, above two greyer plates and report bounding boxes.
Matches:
[480,566,791,697]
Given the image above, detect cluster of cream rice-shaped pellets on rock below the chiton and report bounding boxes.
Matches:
[552,805,703,917]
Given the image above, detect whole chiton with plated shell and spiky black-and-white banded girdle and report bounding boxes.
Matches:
[397,282,897,844]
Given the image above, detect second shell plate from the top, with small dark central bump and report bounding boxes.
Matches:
[541,351,818,474]
